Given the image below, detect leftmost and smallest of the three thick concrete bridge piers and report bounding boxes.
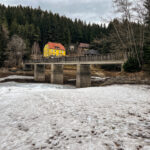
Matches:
[34,64,45,82]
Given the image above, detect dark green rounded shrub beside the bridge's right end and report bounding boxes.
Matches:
[123,57,141,72]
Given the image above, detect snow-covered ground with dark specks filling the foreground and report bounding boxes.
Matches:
[0,82,150,150]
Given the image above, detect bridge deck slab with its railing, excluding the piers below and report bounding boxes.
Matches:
[24,53,126,65]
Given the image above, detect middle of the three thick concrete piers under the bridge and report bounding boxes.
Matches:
[51,64,64,84]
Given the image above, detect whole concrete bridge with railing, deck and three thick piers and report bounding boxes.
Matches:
[24,53,127,88]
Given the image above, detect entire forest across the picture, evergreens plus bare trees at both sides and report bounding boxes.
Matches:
[0,0,150,71]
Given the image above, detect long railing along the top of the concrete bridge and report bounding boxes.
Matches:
[25,53,128,63]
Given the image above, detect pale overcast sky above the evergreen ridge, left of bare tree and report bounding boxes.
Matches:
[0,0,113,23]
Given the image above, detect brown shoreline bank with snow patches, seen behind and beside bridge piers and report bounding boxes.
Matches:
[0,68,150,87]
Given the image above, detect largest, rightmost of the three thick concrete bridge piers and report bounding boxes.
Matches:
[76,64,91,88]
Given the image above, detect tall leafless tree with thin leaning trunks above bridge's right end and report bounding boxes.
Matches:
[113,0,144,67]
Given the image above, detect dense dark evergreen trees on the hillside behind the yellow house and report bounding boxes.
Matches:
[0,5,106,49]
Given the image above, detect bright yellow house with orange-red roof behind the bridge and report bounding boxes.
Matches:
[43,42,66,57]
